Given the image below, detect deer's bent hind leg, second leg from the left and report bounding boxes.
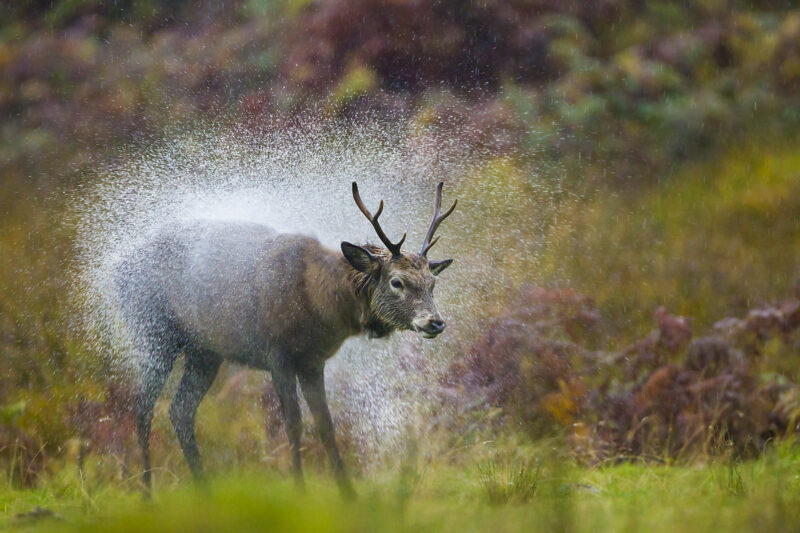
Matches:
[169,348,222,479]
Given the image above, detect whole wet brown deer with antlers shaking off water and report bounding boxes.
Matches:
[114,182,458,497]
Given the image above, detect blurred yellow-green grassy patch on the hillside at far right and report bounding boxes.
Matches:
[537,136,800,342]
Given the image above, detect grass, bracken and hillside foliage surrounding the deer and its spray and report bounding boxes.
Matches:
[0,0,800,531]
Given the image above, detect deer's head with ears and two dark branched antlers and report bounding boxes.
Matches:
[342,182,457,339]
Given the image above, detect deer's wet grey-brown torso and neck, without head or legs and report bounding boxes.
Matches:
[120,222,365,370]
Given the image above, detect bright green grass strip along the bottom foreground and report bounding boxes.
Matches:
[0,436,800,532]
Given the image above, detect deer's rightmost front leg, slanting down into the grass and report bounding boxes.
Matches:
[298,367,355,498]
